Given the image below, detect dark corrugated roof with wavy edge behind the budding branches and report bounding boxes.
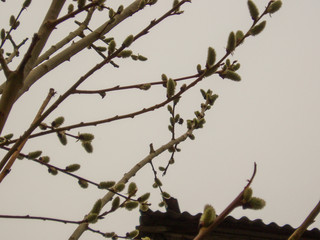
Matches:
[138,205,320,240]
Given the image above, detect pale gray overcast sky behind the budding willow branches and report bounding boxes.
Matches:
[0,0,320,240]
